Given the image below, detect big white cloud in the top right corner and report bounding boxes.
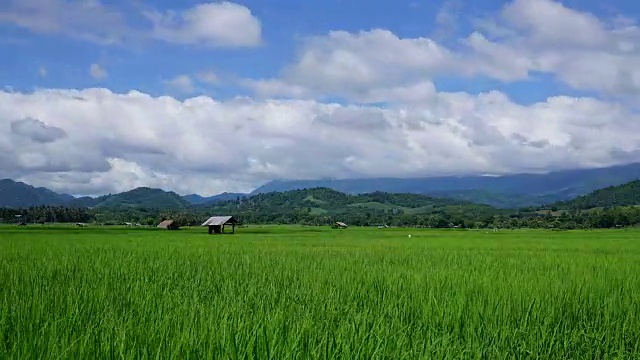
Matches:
[467,0,640,95]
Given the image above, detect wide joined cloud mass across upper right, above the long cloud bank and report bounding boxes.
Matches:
[242,0,640,102]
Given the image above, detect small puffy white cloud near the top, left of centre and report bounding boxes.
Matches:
[146,2,262,47]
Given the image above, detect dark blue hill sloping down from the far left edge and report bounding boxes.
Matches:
[0,179,68,208]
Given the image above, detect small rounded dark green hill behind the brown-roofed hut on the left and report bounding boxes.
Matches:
[95,187,191,209]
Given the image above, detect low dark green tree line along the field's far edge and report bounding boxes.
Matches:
[0,206,640,229]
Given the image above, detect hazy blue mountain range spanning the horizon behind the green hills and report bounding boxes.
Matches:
[0,163,640,209]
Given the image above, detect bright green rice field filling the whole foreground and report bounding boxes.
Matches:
[0,226,640,359]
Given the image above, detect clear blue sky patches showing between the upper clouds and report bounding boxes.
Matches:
[0,0,640,102]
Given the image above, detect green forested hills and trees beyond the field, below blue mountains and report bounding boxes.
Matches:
[0,184,640,229]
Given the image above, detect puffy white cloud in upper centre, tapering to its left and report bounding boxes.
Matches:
[244,29,458,101]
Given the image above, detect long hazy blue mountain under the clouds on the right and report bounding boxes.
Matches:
[251,163,640,208]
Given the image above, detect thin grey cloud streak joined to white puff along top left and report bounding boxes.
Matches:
[0,0,262,47]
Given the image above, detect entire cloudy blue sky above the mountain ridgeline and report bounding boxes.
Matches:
[0,0,640,195]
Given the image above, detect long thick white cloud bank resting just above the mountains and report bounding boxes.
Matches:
[0,89,640,195]
